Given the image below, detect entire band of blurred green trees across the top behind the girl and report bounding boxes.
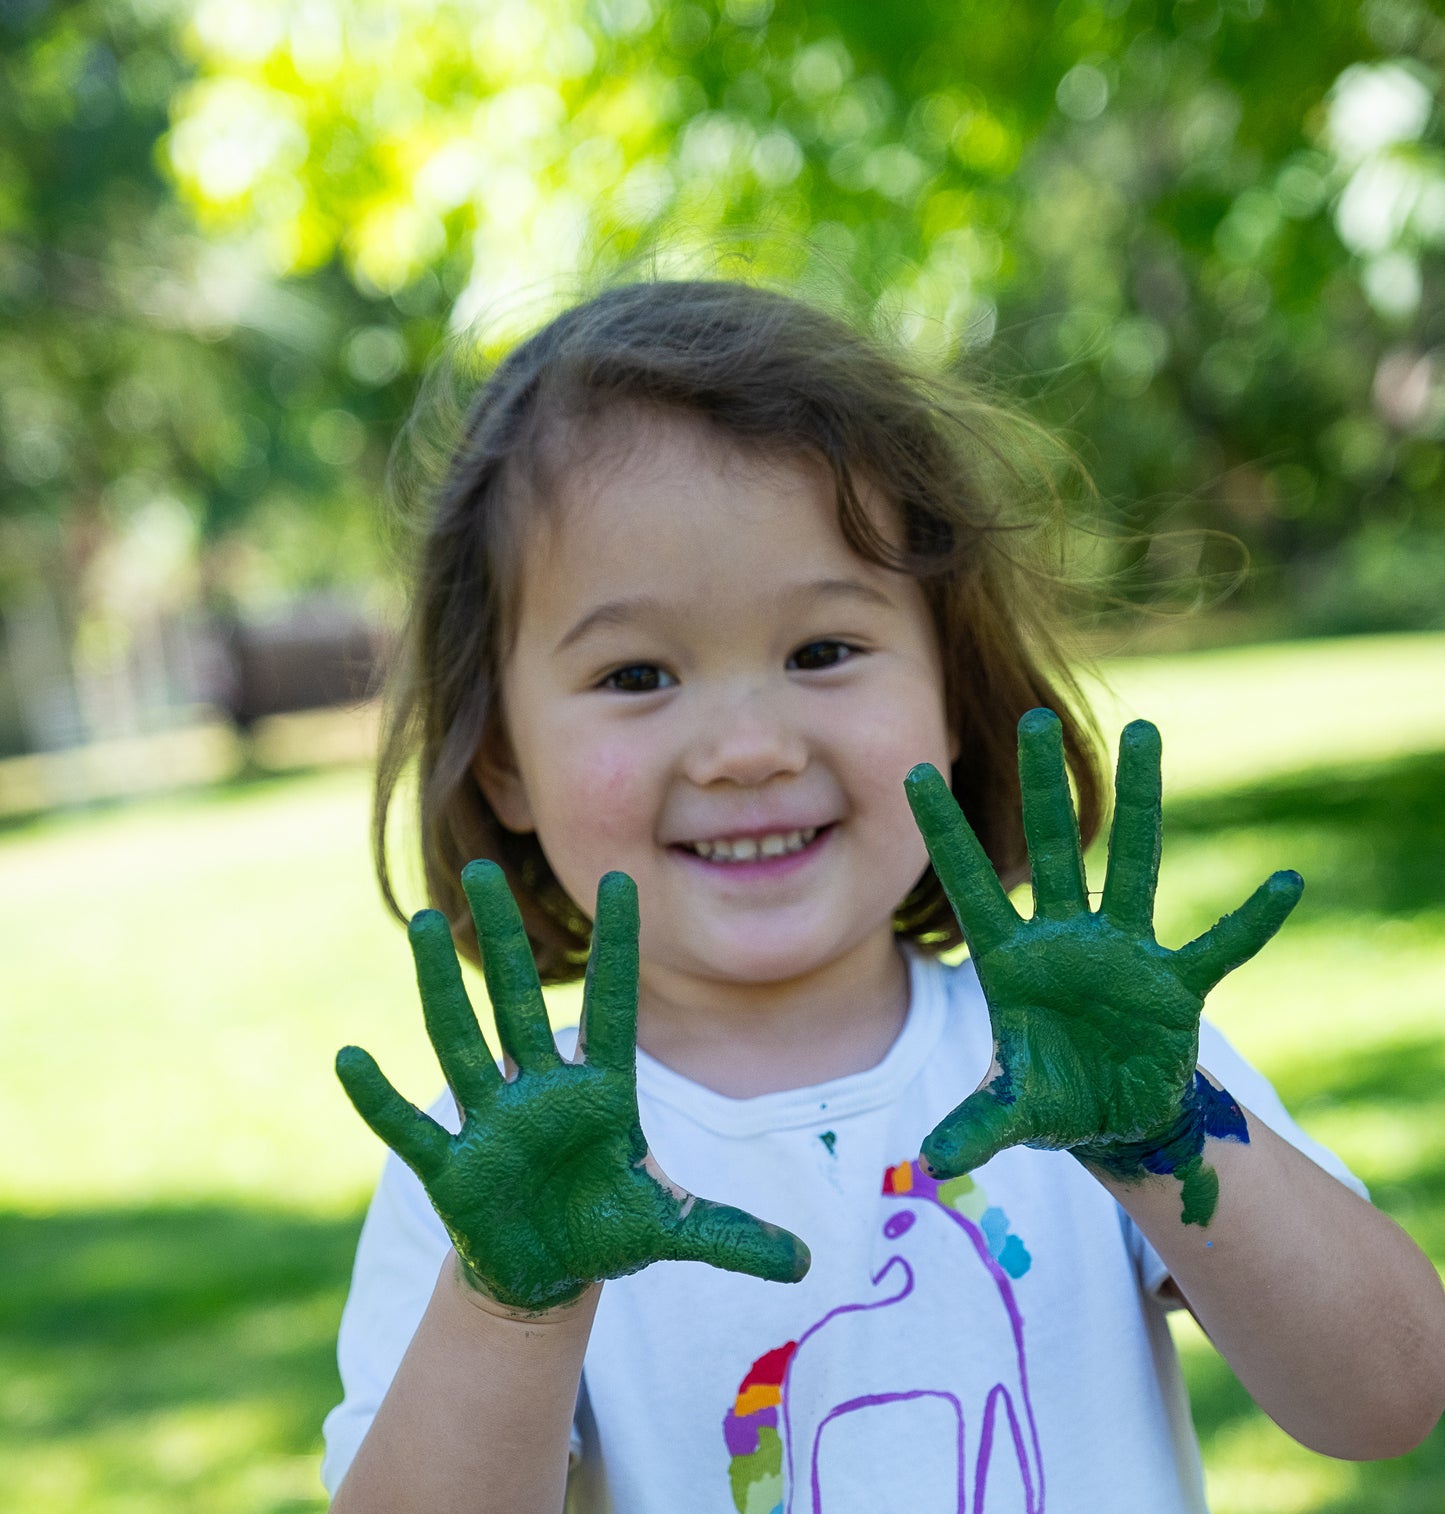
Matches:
[0,0,1445,669]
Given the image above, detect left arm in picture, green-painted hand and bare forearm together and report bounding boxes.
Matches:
[335,863,807,1514]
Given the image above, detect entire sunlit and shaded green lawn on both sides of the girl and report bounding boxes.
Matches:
[0,637,1445,1514]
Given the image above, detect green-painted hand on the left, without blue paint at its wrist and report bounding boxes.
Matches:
[336,861,809,1311]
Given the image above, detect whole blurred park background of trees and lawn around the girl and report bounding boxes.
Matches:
[0,0,1445,1514]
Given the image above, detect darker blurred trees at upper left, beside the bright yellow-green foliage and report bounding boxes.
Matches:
[0,0,427,657]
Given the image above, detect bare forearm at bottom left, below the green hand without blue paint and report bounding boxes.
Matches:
[332,1254,601,1514]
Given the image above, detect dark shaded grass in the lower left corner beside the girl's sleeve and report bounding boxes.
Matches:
[0,1204,360,1514]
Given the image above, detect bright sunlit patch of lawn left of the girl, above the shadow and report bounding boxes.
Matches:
[0,771,577,1207]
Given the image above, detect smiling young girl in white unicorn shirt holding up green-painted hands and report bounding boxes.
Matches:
[324,283,1445,1514]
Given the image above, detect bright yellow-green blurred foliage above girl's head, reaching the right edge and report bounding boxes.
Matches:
[157,0,1445,628]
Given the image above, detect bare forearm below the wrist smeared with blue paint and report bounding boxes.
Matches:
[1101,1111,1445,1459]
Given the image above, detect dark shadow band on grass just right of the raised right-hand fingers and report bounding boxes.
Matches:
[1165,741,1445,914]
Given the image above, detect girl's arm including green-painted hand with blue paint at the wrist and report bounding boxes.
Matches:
[909,710,1445,1458]
